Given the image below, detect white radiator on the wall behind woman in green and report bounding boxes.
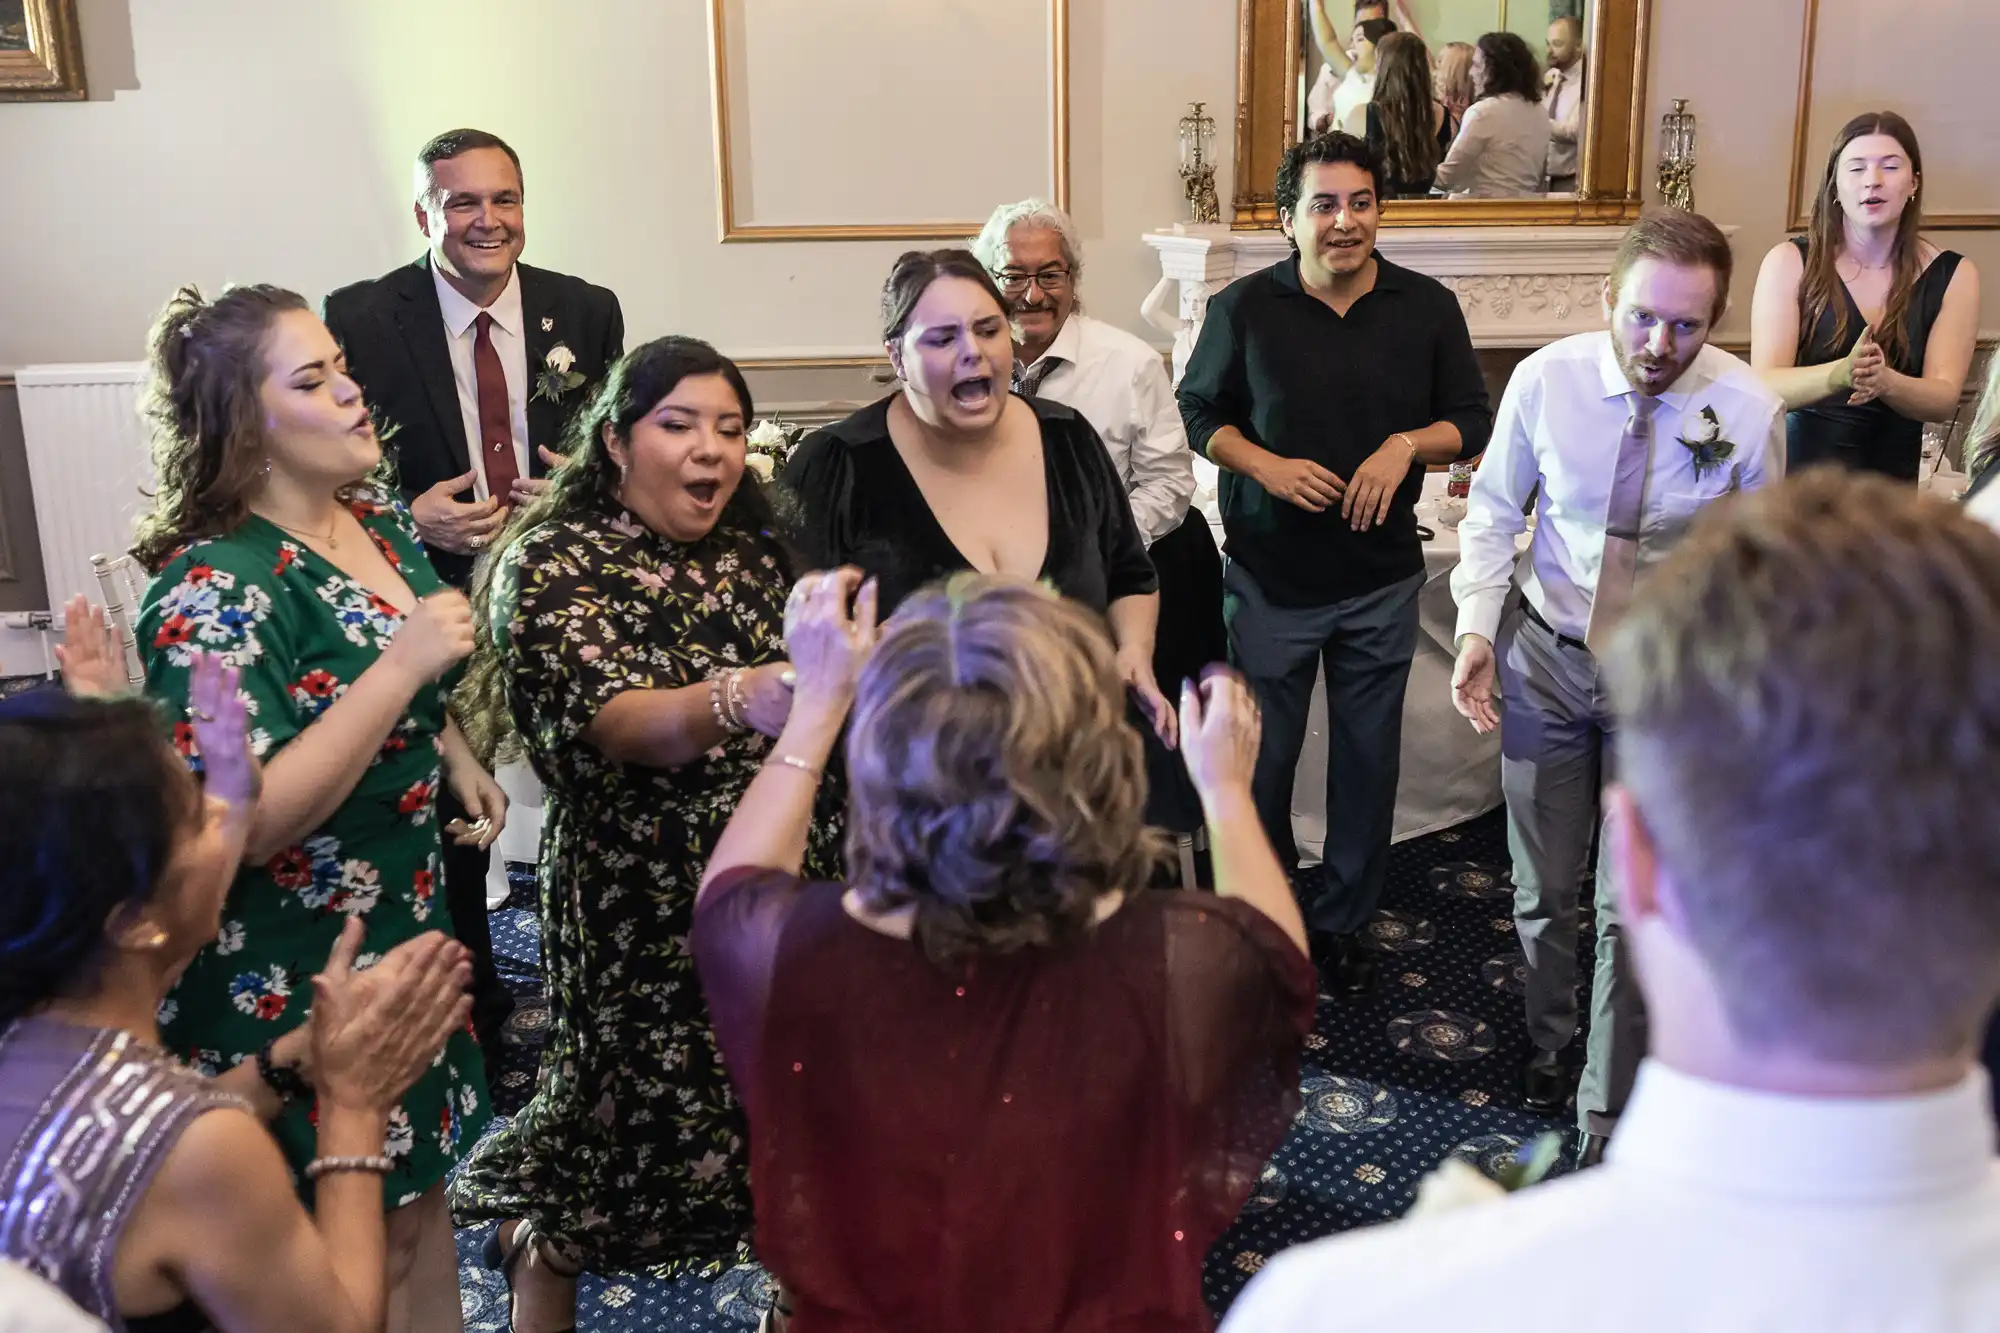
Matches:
[14,362,152,610]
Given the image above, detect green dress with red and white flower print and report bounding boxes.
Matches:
[138,492,490,1207]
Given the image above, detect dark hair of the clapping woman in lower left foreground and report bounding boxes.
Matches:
[0,689,200,1027]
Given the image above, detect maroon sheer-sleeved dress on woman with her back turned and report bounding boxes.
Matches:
[690,871,1318,1333]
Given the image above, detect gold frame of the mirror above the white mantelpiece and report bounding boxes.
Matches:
[1230,0,1654,232]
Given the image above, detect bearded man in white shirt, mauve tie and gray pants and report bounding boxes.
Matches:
[1452,212,1784,1165]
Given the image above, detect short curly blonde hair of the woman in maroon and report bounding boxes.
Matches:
[846,572,1166,963]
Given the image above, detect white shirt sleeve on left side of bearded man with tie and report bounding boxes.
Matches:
[1452,358,1542,642]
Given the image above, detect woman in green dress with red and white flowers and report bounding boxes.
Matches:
[134,286,506,1333]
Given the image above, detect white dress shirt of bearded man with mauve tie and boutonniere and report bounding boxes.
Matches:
[1452,332,1784,642]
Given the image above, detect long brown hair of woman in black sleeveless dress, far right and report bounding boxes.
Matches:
[1798,112,1924,372]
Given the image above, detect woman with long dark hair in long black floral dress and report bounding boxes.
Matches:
[452,338,838,1333]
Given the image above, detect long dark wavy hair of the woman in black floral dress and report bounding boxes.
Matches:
[452,338,796,765]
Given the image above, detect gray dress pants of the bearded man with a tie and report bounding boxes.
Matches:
[1494,608,1646,1135]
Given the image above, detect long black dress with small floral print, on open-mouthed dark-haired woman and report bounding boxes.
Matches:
[452,496,838,1275]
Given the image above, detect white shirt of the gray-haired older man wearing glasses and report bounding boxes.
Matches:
[1028,314,1194,546]
